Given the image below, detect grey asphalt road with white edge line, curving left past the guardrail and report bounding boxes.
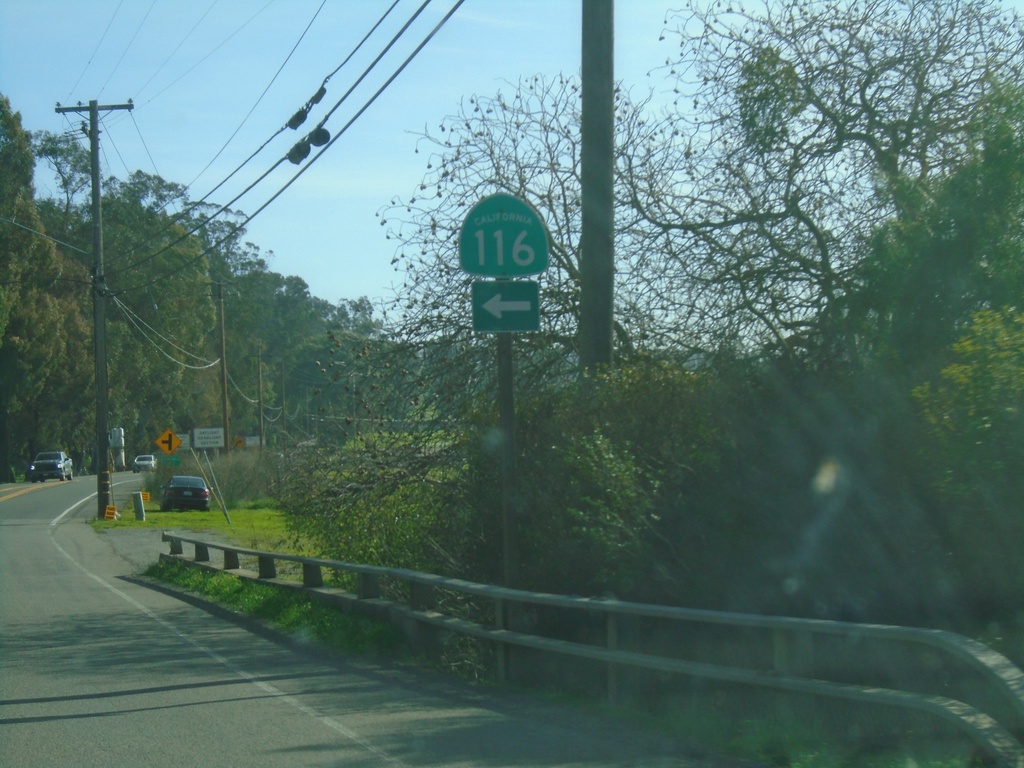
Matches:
[0,473,737,768]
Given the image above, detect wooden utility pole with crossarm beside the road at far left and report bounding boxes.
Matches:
[56,99,134,518]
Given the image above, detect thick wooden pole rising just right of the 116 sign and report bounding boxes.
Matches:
[580,0,615,376]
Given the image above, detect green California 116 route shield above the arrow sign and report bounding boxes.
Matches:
[459,193,548,278]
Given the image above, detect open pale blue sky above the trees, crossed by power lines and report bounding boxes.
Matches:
[0,0,676,309]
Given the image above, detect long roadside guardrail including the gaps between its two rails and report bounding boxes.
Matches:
[161,531,1024,768]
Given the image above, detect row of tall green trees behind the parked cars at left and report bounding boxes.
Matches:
[0,96,380,481]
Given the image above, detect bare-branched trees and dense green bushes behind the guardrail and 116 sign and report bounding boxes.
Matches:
[288,0,1024,625]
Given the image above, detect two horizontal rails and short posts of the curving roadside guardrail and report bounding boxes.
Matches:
[161,531,1024,768]
